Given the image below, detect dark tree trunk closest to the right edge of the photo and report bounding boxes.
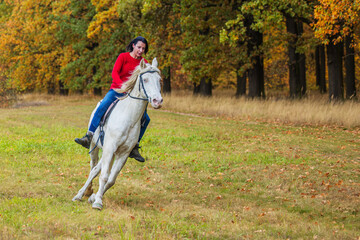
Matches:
[345,35,356,99]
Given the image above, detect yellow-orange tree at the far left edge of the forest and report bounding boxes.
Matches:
[0,0,67,93]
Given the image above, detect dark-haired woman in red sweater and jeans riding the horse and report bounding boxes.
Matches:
[75,36,150,162]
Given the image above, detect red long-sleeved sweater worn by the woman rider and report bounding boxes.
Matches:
[110,52,147,89]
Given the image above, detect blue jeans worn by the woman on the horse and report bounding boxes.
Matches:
[89,89,150,142]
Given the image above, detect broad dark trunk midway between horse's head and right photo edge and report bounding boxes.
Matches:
[245,16,265,98]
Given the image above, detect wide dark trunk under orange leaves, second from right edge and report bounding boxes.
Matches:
[327,41,344,100]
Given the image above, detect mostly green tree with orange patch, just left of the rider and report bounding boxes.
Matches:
[57,1,127,95]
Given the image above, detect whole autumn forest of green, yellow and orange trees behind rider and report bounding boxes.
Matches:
[0,0,360,100]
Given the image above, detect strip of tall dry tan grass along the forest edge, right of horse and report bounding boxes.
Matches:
[164,91,360,127]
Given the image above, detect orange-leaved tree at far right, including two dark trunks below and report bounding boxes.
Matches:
[313,0,360,100]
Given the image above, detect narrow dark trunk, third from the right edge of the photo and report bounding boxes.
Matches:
[315,45,326,93]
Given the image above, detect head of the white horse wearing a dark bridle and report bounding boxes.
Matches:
[139,58,163,109]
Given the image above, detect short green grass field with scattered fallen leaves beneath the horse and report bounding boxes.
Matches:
[0,94,360,239]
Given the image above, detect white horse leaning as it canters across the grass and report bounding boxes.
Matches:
[72,58,163,210]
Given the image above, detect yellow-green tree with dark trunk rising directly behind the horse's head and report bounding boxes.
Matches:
[119,0,181,93]
